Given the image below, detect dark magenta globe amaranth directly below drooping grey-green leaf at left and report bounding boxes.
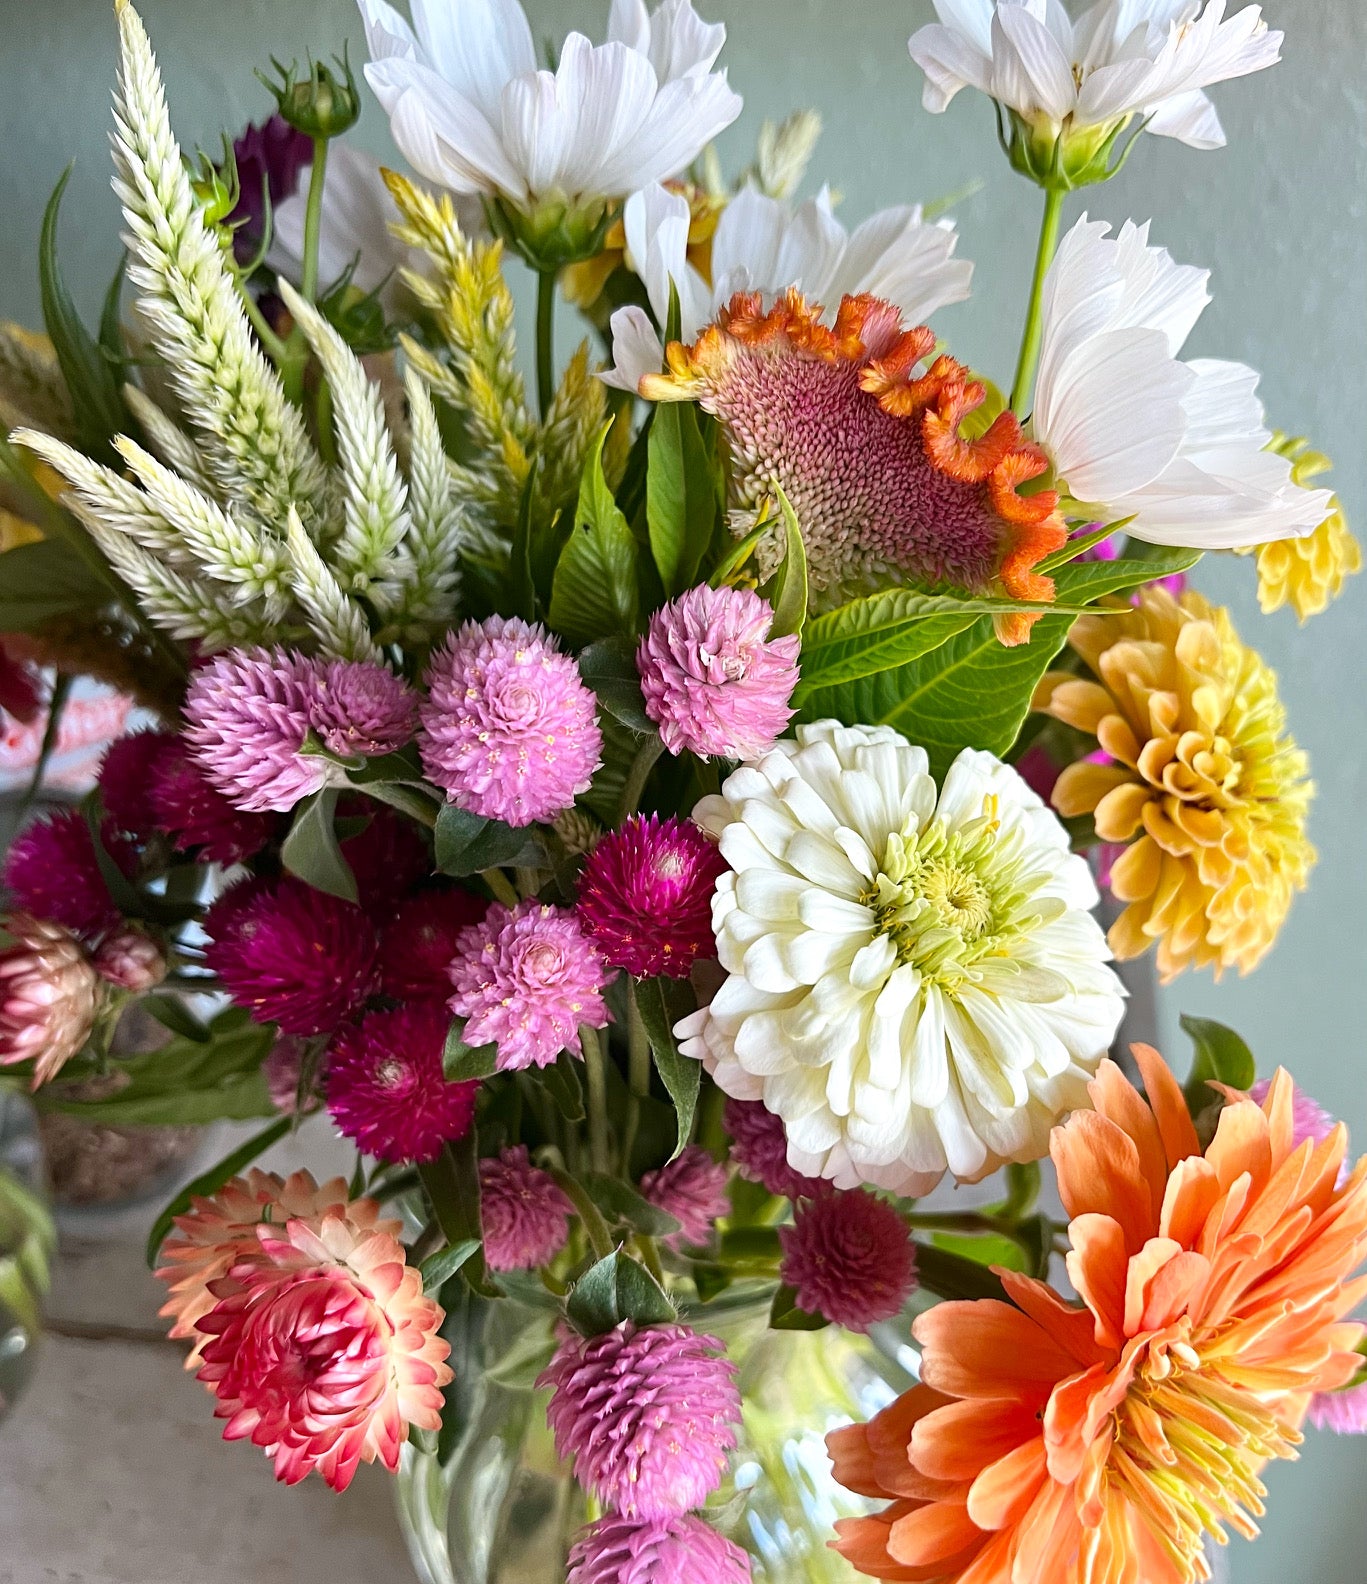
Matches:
[204,876,377,1034]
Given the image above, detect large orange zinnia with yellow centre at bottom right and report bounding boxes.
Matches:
[827,1045,1367,1584]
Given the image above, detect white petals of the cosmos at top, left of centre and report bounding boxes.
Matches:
[360,0,741,211]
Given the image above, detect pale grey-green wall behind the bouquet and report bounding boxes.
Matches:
[0,0,1367,1584]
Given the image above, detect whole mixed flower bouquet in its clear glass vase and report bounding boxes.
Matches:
[0,0,1367,1584]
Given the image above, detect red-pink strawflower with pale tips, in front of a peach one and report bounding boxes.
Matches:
[196,1201,451,1491]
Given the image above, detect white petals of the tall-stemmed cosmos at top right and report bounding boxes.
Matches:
[911,0,1281,149]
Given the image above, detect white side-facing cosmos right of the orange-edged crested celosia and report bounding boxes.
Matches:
[1031,215,1332,550]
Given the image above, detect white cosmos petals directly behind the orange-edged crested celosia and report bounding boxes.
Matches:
[605,182,973,391]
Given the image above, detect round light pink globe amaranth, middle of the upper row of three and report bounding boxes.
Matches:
[420,616,604,825]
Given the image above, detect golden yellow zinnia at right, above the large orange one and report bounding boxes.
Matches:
[1036,588,1315,980]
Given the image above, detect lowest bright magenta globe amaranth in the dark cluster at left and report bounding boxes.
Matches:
[325,1001,478,1166]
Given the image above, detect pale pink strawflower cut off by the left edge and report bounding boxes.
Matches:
[0,912,100,1088]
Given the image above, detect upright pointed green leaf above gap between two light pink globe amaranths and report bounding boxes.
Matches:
[550,423,640,648]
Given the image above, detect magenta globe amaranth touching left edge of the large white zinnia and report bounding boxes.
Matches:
[578,814,725,979]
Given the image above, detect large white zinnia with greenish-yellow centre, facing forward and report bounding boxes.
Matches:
[676,721,1125,1194]
